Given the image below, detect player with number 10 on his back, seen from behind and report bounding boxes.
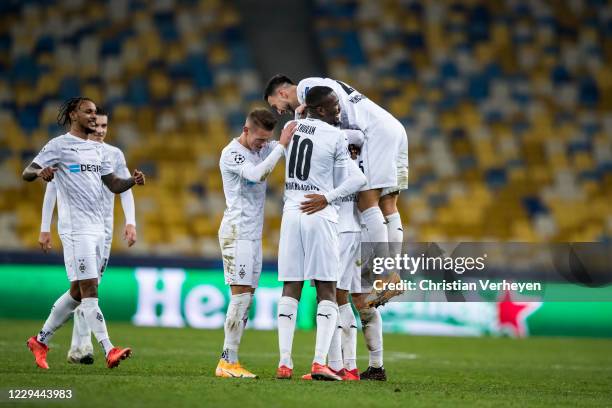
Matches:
[276,86,366,380]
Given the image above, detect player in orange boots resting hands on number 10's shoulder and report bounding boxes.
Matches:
[215,109,296,378]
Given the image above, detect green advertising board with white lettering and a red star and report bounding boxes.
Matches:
[0,265,612,337]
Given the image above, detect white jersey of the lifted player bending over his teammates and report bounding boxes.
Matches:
[297,77,395,132]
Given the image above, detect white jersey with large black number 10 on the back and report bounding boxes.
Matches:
[284,118,351,222]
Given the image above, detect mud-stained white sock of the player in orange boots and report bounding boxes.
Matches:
[221,293,251,363]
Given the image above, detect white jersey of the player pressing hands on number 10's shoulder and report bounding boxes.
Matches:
[219,139,278,240]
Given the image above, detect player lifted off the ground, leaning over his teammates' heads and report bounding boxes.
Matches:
[264,75,408,305]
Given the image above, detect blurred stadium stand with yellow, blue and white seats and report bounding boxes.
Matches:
[0,0,612,265]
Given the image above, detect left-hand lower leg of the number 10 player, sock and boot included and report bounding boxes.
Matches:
[276,281,304,379]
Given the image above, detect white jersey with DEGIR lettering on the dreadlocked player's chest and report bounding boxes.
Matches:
[33,133,113,234]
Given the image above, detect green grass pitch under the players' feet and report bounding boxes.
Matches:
[0,320,612,408]
